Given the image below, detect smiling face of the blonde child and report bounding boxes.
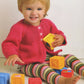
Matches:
[21,1,45,26]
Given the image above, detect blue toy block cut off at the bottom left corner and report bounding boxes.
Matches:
[0,72,10,84]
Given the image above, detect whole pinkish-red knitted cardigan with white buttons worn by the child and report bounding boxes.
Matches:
[2,19,66,65]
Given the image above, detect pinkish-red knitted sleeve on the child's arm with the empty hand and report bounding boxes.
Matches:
[2,25,22,58]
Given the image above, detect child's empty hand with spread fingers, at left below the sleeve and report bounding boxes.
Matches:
[4,55,24,66]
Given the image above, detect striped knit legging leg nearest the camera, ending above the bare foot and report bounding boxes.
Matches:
[21,63,61,84]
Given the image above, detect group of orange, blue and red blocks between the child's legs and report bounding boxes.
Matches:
[50,56,73,78]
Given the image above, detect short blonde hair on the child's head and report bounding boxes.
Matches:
[18,0,50,13]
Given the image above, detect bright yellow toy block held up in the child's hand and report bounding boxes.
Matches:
[43,33,56,50]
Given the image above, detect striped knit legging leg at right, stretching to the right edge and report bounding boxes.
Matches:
[63,54,84,76]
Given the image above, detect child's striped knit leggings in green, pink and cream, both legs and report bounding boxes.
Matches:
[21,54,84,84]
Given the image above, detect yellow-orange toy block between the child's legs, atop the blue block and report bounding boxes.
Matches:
[50,56,65,69]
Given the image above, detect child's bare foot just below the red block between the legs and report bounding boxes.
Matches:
[59,76,80,84]
